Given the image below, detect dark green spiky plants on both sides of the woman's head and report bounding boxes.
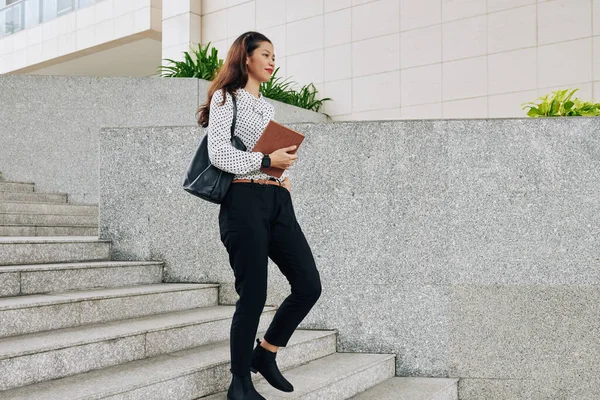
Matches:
[158,43,331,112]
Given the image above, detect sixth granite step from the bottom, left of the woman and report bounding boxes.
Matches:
[0,261,163,297]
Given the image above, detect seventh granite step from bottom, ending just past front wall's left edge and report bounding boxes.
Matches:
[0,236,110,265]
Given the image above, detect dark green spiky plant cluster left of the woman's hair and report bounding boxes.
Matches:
[158,43,223,81]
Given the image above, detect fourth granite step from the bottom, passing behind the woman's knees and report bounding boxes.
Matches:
[0,306,276,390]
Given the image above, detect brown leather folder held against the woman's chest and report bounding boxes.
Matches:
[252,120,304,178]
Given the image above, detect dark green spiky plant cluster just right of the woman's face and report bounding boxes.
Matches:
[260,68,331,112]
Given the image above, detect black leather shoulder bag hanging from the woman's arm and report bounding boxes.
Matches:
[183,96,246,204]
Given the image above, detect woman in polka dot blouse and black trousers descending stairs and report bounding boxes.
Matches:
[198,32,321,400]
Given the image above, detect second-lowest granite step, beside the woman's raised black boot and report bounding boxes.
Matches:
[203,353,396,400]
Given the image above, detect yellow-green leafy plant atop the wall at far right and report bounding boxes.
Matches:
[521,89,600,118]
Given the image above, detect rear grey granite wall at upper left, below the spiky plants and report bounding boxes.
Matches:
[0,75,326,204]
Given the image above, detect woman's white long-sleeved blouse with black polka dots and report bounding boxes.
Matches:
[207,88,288,181]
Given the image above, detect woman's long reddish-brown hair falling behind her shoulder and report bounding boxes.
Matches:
[196,31,271,128]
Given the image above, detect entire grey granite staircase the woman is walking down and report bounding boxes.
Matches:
[0,177,457,400]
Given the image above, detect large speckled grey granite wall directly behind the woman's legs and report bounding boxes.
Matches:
[100,118,600,400]
